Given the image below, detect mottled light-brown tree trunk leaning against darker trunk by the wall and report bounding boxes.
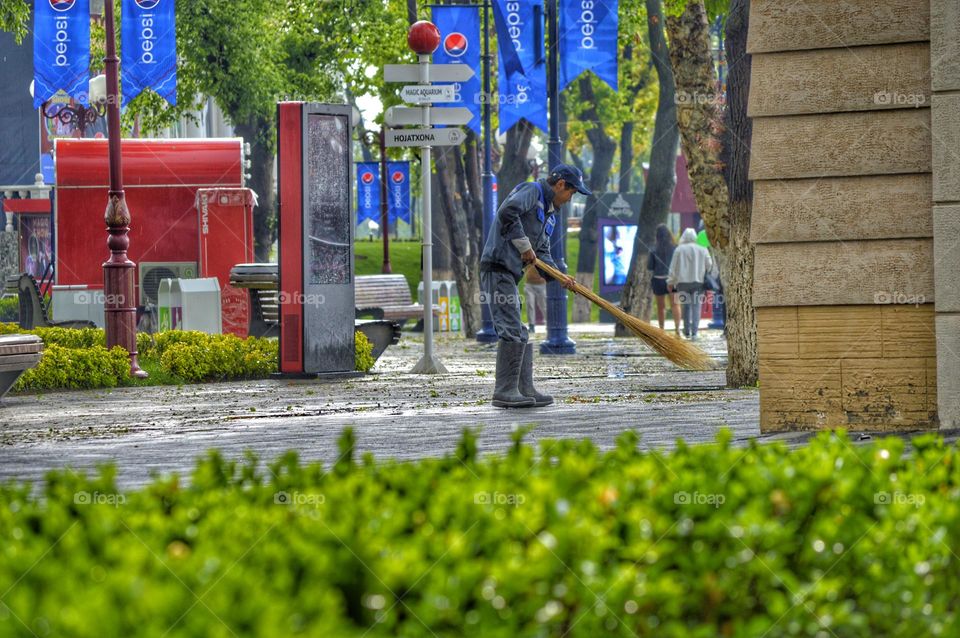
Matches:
[666,0,730,250]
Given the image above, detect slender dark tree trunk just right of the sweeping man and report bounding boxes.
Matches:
[573,74,617,323]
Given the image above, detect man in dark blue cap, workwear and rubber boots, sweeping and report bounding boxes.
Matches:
[480,164,590,408]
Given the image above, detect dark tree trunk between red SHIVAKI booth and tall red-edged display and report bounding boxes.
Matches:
[234,118,277,262]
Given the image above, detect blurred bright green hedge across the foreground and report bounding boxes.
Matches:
[0,434,960,638]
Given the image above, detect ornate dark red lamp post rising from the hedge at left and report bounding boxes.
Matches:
[103,0,147,378]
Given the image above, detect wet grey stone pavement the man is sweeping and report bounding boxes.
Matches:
[0,326,944,488]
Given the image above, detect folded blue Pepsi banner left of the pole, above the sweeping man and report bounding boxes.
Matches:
[494,0,547,133]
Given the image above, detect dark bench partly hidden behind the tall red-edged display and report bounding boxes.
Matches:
[230,264,400,361]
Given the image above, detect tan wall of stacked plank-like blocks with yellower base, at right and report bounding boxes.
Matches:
[748,0,940,431]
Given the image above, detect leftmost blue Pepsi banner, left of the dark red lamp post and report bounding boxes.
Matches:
[33,0,90,109]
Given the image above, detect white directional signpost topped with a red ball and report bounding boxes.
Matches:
[383,20,473,374]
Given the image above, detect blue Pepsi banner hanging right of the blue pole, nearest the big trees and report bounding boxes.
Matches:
[559,0,619,91]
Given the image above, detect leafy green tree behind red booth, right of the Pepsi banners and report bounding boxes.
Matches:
[126,0,403,260]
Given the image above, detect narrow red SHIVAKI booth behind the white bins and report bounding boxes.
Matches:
[197,188,256,338]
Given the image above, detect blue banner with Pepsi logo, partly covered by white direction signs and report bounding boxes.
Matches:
[432,5,483,135]
